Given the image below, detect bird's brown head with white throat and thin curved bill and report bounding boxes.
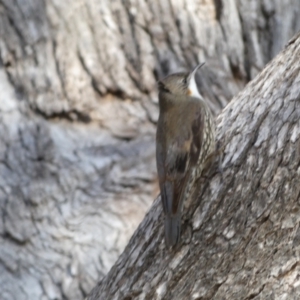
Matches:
[158,63,204,99]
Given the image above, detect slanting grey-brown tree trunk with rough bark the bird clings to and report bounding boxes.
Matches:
[88,34,300,300]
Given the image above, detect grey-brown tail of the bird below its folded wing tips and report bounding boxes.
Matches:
[165,214,181,248]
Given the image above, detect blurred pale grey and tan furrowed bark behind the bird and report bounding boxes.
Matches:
[0,0,300,300]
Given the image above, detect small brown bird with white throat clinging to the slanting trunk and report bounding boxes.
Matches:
[156,64,215,247]
